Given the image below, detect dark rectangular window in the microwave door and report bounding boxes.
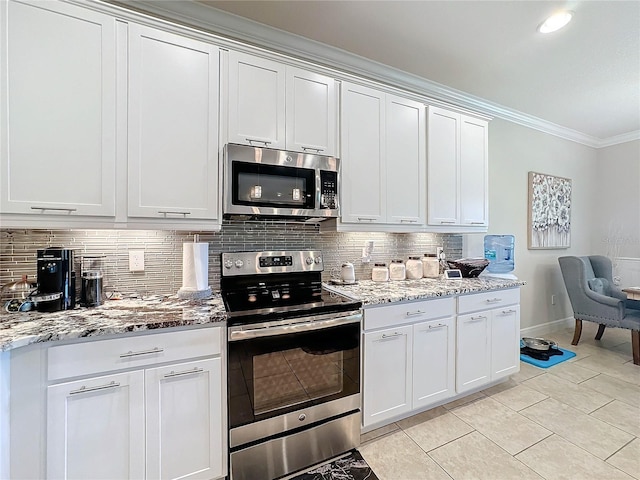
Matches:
[232,162,316,209]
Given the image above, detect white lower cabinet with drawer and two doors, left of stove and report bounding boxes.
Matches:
[46,327,226,480]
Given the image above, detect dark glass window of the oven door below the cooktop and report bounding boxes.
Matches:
[229,323,360,427]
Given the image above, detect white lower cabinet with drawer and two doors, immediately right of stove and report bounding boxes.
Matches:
[362,297,455,427]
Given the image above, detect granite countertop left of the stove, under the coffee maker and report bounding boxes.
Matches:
[0,294,227,351]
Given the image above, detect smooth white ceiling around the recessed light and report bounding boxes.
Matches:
[200,0,640,143]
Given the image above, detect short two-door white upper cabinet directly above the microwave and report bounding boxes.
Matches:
[228,52,337,156]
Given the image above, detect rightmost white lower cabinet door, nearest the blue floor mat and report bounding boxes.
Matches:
[491,305,520,380]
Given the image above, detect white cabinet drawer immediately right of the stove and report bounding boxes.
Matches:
[364,297,455,330]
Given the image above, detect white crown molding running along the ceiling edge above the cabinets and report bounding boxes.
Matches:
[107,0,640,148]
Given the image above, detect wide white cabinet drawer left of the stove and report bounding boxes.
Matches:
[47,327,221,381]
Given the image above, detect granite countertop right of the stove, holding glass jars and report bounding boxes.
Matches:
[325,277,526,307]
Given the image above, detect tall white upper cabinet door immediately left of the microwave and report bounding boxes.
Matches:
[128,24,219,219]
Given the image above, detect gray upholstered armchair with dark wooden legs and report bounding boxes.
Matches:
[558,255,640,365]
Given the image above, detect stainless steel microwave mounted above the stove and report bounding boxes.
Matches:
[223,143,340,220]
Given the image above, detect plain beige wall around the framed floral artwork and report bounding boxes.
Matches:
[472,119,599,329]
